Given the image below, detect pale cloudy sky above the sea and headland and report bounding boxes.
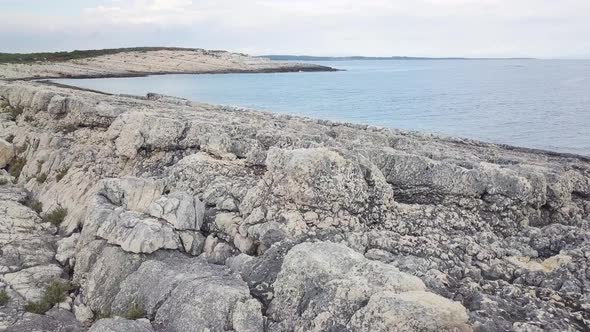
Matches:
[0,0,590,58]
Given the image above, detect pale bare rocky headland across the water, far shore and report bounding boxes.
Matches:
[0,49,335,80]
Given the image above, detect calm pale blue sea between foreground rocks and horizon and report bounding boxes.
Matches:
[56,60,590,155]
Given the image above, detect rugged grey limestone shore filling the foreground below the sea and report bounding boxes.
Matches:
[0,78,590,332]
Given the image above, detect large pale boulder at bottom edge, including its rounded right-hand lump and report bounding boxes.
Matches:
[267,242,467,331]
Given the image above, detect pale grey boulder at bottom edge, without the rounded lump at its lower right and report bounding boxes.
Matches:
[268,242,444,330]
